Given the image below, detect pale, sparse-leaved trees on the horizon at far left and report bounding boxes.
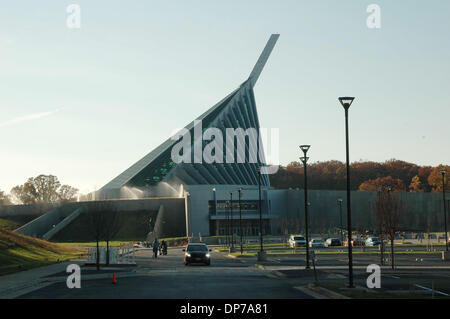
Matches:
[0,174,78,205]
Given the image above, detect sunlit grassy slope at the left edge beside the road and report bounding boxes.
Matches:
[0,229,82,276]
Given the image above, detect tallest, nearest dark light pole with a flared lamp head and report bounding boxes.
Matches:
[339,97,355,288]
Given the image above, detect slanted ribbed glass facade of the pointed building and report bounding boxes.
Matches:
[126,81,270,187]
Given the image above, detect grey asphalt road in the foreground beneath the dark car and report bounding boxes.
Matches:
[19,248,312,299]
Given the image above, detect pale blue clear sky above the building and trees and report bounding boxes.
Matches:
[0,0,450,192]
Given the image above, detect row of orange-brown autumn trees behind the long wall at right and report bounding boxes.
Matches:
[270,159,450,192]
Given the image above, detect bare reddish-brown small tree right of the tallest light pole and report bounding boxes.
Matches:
[373,187,403,269]
